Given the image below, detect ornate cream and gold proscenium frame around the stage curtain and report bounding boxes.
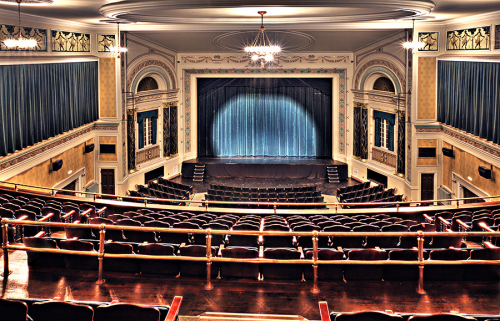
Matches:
[183,69,347,155]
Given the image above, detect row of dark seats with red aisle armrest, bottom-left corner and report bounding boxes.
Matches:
[0,297,182,321]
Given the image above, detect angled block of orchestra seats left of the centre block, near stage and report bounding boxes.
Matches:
[129,177,193,205]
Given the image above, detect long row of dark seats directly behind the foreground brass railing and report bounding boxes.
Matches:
[21,237,500,281]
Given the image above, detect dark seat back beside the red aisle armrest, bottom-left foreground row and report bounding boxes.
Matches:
[94,303,160,321]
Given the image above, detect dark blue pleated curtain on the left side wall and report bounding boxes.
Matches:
[0,62,99,156]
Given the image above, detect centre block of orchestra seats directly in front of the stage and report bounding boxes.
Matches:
[205,184,326,209]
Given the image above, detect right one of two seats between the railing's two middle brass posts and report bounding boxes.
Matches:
[261,248,302,280]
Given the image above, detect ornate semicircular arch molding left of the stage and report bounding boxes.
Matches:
[127,59,177,93]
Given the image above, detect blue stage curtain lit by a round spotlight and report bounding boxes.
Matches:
[198,78,332,157]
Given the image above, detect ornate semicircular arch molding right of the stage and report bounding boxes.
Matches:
[353,58,406,94]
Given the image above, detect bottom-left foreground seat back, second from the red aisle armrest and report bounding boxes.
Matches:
[29,301,94,321]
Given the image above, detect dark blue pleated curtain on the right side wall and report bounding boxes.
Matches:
[437,61,500,144]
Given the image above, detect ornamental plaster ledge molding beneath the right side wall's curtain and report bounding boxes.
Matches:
[415,124,500,158]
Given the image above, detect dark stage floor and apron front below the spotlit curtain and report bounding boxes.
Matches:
[182,157,348,180]
